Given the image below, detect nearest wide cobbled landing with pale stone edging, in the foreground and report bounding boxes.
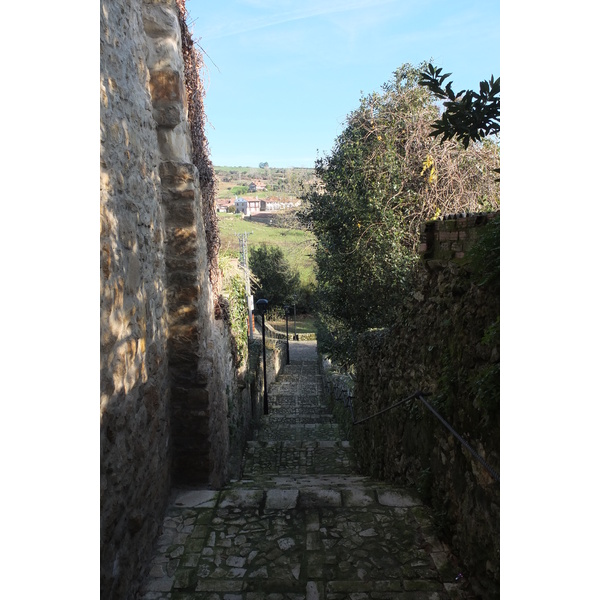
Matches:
[142,476,460,600]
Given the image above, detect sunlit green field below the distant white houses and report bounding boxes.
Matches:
[219,213,315,283]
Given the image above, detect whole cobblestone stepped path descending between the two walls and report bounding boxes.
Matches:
[141,342,474,600]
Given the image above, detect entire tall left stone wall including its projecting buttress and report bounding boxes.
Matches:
[100,0,252,600]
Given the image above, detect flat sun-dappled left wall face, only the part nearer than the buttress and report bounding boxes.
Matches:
[100,0,171,598]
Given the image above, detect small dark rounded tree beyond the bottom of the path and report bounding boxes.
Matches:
[250,243,300,308]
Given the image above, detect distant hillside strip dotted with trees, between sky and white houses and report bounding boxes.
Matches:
[214,167,315,200]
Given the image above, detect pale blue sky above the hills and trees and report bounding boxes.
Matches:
[186,0,500,167]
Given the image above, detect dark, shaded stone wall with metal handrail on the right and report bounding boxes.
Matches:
[351,213,500,598]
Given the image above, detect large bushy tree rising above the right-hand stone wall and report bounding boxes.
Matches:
[301,64,499,365]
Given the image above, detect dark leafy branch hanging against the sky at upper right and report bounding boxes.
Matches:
[419,63,500,148]
